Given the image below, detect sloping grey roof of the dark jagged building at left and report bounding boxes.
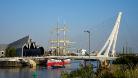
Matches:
[8,36,30,48]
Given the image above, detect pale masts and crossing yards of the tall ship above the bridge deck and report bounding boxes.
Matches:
[50,23,72,55]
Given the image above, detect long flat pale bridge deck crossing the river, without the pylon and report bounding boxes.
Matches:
[0,56,118,61]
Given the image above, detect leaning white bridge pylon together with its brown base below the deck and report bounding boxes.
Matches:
[97,12,122,68]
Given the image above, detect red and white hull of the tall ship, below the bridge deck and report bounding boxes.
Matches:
[47,59,71,67]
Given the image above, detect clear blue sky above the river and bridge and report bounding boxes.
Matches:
[0,0,138,52]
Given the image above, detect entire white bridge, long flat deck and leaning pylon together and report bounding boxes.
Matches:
[0,12,122,62]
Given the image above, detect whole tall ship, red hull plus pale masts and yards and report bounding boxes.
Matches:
[47,24,73,66]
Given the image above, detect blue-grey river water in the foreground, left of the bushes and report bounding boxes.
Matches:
[0,61,81,78]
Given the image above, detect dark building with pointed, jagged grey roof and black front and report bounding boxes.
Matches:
[8,36,44,57]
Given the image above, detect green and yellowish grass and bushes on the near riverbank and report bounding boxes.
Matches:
[61,55,138,78]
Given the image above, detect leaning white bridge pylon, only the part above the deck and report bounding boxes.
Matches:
[97,12,122,57]
